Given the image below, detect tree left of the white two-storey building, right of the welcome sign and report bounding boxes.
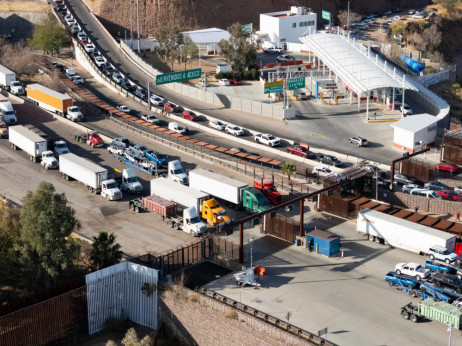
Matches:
[218,23,260,72]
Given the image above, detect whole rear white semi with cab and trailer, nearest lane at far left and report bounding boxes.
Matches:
[8,125,58,169]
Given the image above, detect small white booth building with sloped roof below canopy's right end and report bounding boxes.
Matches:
[391,114,438,154]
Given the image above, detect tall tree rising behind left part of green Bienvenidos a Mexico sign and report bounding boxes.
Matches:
[156,25,184,71]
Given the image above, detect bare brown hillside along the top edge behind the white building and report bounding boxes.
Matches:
[82,0,428,37]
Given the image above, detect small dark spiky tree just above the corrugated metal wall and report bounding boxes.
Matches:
[90,231,123,270]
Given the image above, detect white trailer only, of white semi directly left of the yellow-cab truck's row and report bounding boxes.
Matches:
[59,153,108,192]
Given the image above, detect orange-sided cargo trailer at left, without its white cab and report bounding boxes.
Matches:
[27,84,72,116]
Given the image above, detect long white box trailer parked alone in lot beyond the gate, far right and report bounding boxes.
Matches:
[356,209,456,254]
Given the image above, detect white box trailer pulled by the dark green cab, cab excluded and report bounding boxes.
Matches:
[189,168,249,205]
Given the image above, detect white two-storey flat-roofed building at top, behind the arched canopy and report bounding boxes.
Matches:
[260,6,316,47]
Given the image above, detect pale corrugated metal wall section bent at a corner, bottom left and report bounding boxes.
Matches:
[86,262,158,334]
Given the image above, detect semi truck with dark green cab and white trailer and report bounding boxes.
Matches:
[189,168,270,212]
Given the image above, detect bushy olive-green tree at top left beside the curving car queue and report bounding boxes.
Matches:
[29,19,72,55]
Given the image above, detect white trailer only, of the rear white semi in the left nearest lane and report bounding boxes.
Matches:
[9,125,47,162]
